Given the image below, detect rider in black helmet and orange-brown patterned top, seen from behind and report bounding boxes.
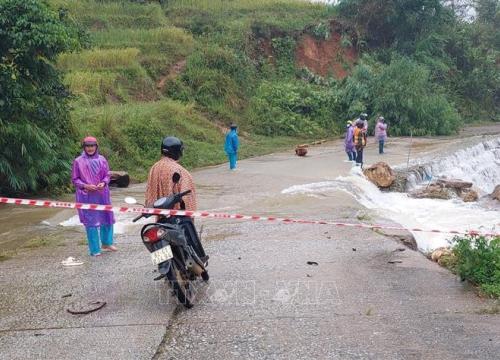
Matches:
[145,136,196,211]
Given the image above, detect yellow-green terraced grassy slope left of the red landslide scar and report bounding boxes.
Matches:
[50,0,334,180]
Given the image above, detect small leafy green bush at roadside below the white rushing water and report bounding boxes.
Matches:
[453,235,500,297]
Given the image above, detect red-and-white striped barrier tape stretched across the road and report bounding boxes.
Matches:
[0,197,500,237]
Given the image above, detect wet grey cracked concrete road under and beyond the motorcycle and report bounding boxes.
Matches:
[0,139,500,359]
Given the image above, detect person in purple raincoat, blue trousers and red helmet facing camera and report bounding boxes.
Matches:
[71,136,117,256]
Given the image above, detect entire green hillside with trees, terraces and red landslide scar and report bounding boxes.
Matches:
[0,0,500,193]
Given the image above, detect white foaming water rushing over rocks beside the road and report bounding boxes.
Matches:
[283,138,500,251]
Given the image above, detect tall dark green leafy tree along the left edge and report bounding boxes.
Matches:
[0,0,80,193]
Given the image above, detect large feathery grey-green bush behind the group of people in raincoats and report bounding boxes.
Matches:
[342,57,462,136]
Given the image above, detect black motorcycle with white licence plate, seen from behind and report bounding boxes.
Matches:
[125,173,209,309]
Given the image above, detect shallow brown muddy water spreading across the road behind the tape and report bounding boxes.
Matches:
[0,129,498,250]
